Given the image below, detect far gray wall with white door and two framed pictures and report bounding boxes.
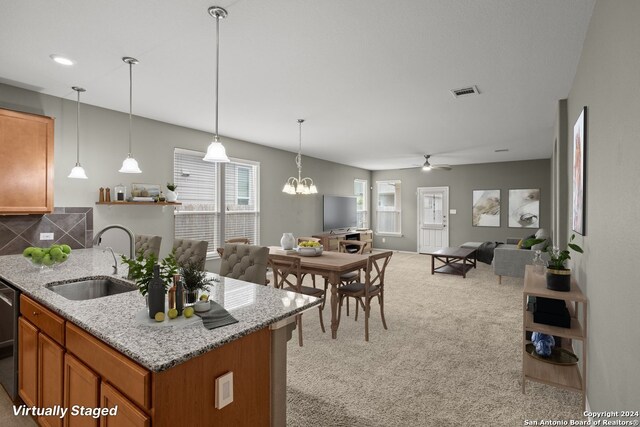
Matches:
[371,159,551,252]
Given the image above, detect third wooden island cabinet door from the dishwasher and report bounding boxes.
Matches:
[64,353,100,427]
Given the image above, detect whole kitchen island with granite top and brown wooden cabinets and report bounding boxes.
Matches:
[0,249,320,426]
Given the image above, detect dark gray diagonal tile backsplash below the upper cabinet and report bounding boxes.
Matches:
[0,207,93,255]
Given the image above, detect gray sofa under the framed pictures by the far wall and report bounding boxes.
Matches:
[492,228,551,283]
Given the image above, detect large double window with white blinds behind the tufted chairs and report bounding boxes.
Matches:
[173,148,260,258]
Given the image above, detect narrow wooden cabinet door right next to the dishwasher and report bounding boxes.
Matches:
[18,317,38,406]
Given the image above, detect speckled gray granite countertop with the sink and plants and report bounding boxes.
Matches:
[0,249,320,372]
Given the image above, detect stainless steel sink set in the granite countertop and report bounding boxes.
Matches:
[45,277,138,301]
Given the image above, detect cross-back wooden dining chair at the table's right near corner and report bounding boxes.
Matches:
[338,251,393,341]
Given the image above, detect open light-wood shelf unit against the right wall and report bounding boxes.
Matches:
[522,265,587,408]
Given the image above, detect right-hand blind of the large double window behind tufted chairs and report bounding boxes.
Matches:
[224,159,260,245]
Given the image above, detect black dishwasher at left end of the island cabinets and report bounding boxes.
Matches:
[0,279,20,401]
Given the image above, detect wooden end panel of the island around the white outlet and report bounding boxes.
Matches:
[153,328,271,427]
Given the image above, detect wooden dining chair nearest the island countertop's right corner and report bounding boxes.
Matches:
[269,255,325,347]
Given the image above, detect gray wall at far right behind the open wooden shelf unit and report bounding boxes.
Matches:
[565,0,640,411]
